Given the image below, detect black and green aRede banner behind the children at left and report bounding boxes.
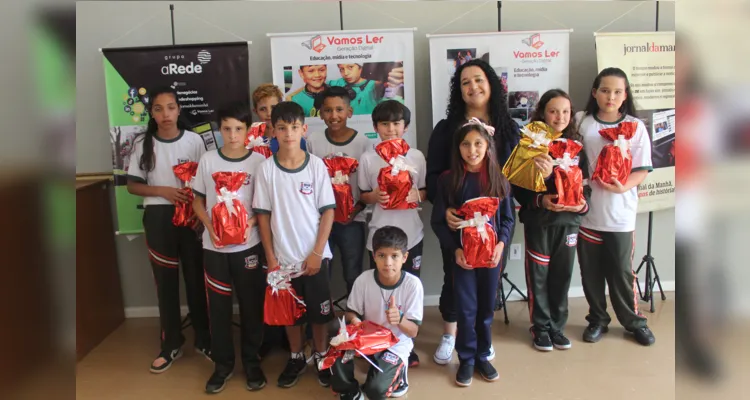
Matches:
[101,42,250,234]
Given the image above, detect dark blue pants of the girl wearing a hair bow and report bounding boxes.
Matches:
[453,263,500,365]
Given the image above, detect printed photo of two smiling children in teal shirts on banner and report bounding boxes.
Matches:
[284,61,404,117]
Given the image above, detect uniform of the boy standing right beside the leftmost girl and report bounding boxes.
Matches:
[193,149,267,373]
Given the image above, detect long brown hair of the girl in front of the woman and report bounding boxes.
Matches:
[448,124,510,206]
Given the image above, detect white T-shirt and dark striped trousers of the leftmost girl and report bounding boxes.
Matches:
[126,130,211,351]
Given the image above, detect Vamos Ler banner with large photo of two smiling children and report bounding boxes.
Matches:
[268,28,417,148]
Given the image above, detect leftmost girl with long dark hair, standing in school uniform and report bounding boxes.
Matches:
[127,87,211,374]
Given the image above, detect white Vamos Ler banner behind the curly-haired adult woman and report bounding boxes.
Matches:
[427,29,572,126]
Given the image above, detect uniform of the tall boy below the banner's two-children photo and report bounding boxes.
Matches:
[308,130,372,293]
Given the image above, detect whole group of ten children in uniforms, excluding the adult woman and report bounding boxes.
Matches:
[128,68,654,399]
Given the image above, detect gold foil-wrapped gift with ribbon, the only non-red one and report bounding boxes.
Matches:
[503,121,562,192]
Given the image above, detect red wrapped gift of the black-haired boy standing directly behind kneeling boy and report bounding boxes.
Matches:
[375,139,419,210]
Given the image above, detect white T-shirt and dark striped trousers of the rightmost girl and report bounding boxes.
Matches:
[576,112,653,331]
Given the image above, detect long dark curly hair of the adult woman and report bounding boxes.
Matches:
[446,58,518,139]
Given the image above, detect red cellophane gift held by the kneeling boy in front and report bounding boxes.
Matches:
[318,317,398,371]
